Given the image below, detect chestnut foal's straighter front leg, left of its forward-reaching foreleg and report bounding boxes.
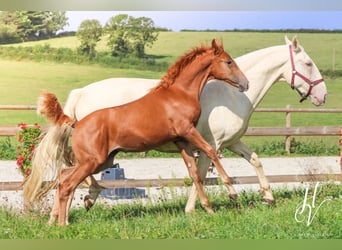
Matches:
[175,141,214,214]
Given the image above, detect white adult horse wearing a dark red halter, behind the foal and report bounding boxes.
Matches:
[26,37,327,213]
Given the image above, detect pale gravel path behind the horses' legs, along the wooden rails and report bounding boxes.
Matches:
[0,157,340,209]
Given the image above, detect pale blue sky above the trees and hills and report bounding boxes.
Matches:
[64,10,342,31]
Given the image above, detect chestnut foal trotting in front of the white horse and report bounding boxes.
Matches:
[24,40,248,225]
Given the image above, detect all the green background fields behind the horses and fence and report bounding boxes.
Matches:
[0,32,342,153]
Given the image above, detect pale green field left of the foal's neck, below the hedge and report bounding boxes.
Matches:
[0,59,160,125]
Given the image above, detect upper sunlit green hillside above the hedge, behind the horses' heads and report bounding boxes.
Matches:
[2,32,342,70]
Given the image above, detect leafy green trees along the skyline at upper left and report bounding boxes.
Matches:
[0,11,160,58]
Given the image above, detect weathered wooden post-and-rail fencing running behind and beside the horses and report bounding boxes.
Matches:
[0,105,342,191]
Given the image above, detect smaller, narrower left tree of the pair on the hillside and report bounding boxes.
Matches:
[76,20,102,57]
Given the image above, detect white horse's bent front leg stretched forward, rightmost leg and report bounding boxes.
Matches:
[229,141,274,204]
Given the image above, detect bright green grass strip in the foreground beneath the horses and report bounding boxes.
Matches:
[0,184,342,239]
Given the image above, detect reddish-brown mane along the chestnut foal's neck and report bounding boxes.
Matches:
[154,45,212,90]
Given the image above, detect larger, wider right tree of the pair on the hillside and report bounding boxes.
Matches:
[105,14,158,57]
